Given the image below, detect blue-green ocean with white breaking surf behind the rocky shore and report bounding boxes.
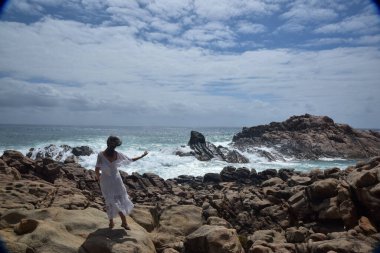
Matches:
[0,125,356,179]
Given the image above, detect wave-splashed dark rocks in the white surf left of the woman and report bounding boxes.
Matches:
[26,144,94,162]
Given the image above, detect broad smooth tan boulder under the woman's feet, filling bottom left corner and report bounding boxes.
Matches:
[0,208,156,253]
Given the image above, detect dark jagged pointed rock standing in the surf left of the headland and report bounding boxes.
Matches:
[176,131,249,163]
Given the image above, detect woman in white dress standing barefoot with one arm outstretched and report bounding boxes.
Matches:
[95,136,148,230]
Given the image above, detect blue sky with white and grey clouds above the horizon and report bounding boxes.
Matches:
[0,0,380,128]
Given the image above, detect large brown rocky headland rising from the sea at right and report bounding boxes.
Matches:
[233,114,380,159]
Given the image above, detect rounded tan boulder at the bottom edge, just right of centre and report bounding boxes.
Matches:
[185,225,244,253]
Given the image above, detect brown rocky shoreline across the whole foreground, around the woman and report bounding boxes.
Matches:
[0,151,380,253]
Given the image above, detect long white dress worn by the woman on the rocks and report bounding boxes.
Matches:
[96,152,134,219]
